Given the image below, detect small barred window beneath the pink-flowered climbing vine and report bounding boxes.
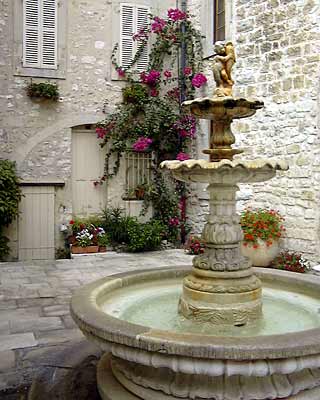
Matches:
[125,152,152,199]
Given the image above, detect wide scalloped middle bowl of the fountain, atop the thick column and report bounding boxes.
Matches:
[161,159,288,185]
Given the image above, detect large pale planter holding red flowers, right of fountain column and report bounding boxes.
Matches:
[241,240,279,267]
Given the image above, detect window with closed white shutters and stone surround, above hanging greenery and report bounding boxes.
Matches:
[10,0,66,79]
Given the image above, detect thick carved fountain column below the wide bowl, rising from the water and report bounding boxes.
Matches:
[179,183,262,325]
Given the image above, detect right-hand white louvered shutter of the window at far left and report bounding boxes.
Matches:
[41,0,57,69]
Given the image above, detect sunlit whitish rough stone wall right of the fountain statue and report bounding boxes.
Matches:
[190,0,320,262]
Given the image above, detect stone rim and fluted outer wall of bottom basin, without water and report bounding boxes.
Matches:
[71,267,320,400]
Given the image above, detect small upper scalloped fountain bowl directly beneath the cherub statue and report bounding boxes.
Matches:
[183,97,263,120]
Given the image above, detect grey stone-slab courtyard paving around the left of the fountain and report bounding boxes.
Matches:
[0,250,191,390]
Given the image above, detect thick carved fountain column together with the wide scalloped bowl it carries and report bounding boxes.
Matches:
[161,156,287,326]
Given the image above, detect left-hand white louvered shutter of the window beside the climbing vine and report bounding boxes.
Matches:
[120,4,135,68]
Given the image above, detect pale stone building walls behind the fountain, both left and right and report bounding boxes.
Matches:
[0,0,320,262]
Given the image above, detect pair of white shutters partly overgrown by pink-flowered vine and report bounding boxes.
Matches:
[120,3,149,71]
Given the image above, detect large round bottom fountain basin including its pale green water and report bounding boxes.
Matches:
[71,267,320,400]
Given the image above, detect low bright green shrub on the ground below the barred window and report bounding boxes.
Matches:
[128,219,166,252]
